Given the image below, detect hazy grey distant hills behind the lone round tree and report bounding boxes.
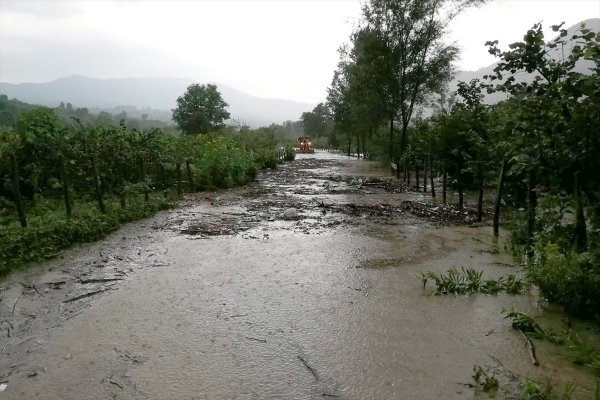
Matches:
[0,75,315,127]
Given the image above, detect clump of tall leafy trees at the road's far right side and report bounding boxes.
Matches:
[326,0,483,162]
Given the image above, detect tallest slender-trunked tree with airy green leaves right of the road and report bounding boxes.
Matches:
[361,0,485,174]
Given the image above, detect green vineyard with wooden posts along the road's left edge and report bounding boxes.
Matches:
[0,108,290,275]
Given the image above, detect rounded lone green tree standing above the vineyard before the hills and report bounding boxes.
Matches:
[171,83,230,135]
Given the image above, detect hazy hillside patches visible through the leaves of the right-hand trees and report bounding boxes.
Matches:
[449,18,600,104]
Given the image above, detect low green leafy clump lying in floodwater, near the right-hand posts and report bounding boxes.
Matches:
[421,267,525,295]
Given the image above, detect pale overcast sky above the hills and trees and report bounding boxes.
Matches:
[0,0,600,103]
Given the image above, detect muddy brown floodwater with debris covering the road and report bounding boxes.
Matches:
[0,152,591,400]
